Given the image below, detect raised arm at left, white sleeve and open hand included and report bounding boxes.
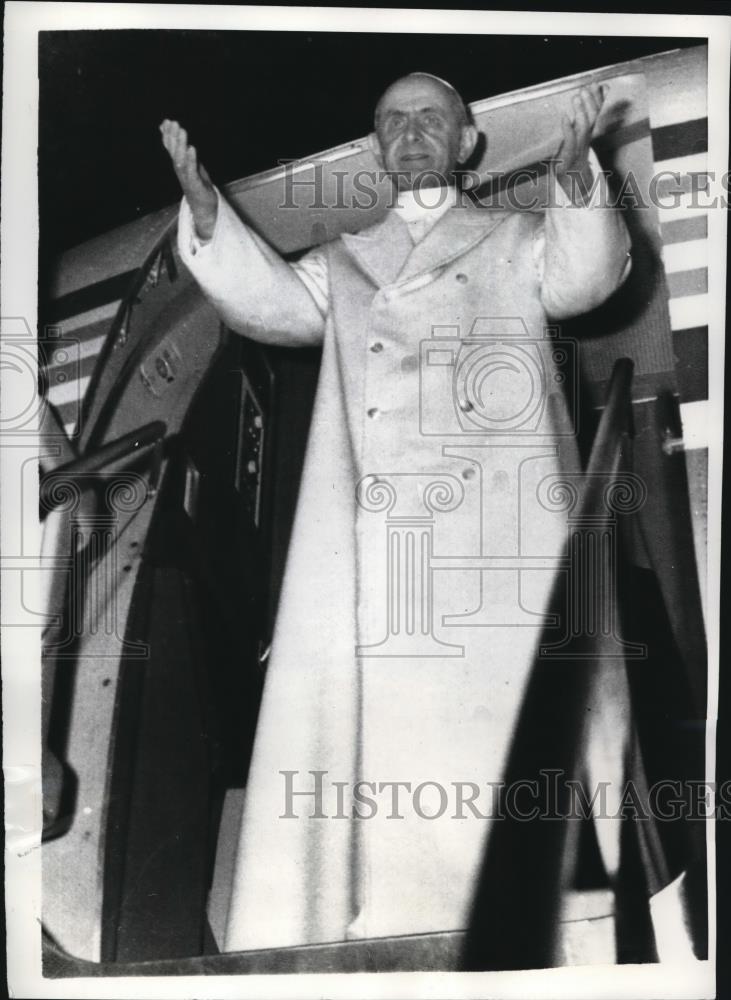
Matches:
[160,119,325,346]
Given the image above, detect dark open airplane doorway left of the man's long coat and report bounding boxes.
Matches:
[97,334,316,962]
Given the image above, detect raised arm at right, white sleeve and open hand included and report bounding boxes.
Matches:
[540,86,631,319]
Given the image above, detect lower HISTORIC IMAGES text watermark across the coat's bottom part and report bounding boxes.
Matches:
[279,768,731,823]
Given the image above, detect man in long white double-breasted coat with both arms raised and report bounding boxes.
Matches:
[161,74,630,950]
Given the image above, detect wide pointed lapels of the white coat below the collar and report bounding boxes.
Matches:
[342,199,509,288]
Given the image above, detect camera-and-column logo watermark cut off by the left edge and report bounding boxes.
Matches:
[0,317,150,660]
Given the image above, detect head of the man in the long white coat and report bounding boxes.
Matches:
[376,76,477,188]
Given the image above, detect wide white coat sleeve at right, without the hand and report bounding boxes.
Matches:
[534,150,631,319]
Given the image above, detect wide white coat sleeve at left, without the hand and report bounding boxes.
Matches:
[178,191,325,346]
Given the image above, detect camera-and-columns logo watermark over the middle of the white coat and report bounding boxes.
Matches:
[356,317,647,660]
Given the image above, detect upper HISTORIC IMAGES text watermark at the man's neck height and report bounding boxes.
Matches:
[277,160,731,212]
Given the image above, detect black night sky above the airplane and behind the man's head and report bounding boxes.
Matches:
[39,30,698,260]
